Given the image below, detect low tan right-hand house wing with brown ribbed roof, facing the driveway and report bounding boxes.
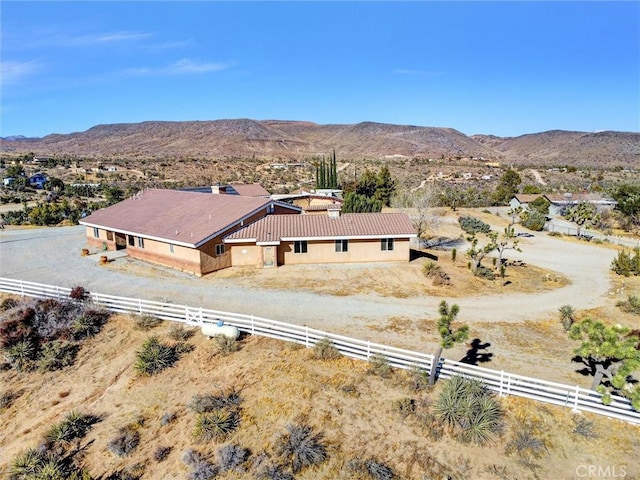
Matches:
[224,208,416,268]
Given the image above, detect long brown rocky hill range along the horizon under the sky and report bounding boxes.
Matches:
[1,119,640,166]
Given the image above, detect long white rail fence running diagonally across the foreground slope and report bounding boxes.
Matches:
[0,278,640,425]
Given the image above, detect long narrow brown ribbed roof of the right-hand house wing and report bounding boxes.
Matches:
[225,213,416,243]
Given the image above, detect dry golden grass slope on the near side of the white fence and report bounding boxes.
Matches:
[0,316,640,480]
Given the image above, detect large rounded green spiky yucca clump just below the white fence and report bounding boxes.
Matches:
[434,376,502,444]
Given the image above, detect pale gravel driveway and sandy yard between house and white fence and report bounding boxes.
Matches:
[0,217,635,386]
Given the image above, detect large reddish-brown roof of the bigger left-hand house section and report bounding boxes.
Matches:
[80,189,276,247]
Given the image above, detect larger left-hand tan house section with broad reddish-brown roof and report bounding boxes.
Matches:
[80,189,300,275]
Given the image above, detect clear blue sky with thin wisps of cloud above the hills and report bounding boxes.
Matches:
[0,1,640,136]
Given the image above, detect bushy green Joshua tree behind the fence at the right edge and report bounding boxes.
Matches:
[569,319,640,411]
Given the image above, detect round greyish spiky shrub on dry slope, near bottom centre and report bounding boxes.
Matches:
[275,424,327,473]
